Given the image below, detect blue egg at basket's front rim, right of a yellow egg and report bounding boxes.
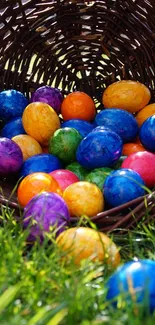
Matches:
[103,168,145,207]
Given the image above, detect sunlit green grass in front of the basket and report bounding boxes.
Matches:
[0,205,155,325]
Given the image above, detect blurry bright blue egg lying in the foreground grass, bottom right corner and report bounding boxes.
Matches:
[106,260,155,312]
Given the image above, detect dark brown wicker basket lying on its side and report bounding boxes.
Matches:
[0,0,155,231]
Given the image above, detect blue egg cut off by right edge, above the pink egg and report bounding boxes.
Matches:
[139,115,155,152]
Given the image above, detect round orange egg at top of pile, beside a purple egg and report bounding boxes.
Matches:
[61,91,96,121]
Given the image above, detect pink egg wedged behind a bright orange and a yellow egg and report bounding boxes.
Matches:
[50,169,79,191]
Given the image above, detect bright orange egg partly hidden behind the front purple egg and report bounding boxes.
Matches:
[17,173,62,207]
